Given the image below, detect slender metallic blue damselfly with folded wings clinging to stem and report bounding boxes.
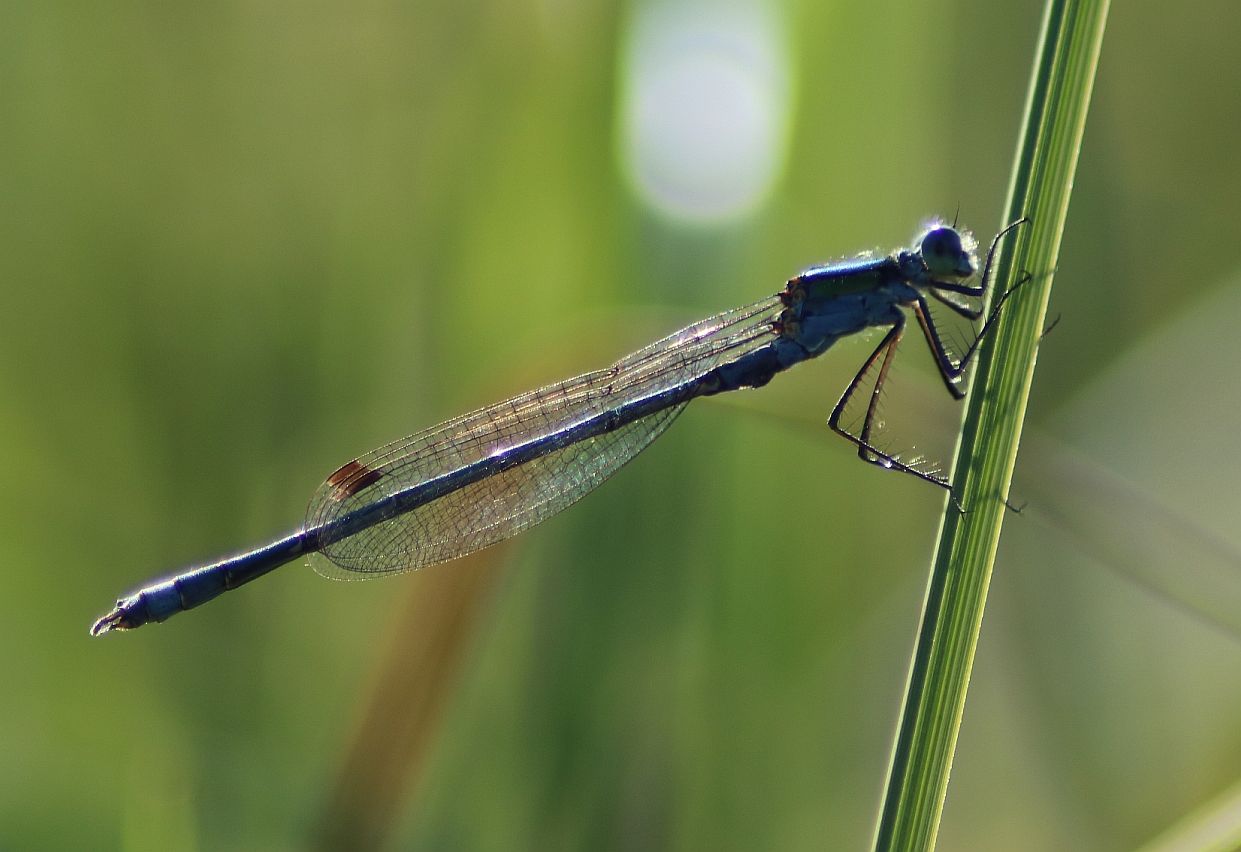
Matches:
[91,220,1025,635]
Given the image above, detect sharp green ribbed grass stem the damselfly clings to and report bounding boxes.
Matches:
[875,0,1108,850]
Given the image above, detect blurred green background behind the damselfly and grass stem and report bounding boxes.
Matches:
[0,0,1241,850]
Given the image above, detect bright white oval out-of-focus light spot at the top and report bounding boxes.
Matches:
[618,2,789,223]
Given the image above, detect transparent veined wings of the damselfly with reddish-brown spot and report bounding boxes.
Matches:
[307,296,781,579]
